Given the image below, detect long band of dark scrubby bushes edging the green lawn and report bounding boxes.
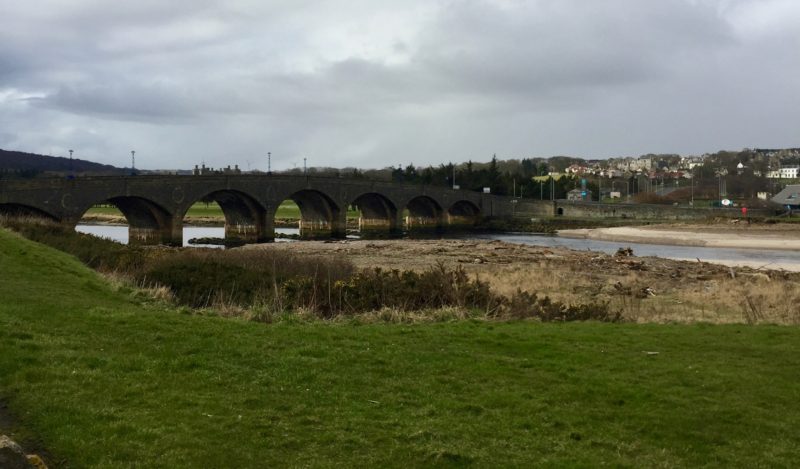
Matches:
[0,218,621,322]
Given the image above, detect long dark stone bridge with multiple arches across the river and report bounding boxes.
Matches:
[0,174,515,246]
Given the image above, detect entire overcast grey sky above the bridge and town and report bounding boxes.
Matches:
[0,0,800,170]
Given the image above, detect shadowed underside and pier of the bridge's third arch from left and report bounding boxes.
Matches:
[188,189,273,243]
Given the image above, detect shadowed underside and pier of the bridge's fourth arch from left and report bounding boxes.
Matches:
[279,189,346,239]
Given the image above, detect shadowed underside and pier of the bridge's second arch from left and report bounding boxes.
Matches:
[80,196,178,246]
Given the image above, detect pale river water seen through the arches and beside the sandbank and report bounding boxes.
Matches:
[76,225,800,271]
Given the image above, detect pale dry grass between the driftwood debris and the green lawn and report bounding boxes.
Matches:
[476,261,800,324]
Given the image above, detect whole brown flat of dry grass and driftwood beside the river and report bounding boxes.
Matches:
[250,240,800,324]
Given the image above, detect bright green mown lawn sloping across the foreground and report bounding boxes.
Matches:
[0,230,800,467]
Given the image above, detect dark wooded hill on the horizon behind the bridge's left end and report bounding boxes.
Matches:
[0,149,125,175]
